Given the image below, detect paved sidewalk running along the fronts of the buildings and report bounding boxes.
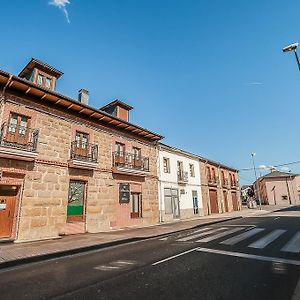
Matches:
[0,208,273,269]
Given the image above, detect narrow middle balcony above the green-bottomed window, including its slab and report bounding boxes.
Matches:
[69,141,98,170]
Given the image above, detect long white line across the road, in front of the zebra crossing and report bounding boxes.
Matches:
[196,248,300,266]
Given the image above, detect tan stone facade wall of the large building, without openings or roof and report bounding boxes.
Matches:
[0,88,158,241]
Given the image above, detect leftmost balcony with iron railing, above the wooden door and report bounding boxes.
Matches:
[0,123,39,161]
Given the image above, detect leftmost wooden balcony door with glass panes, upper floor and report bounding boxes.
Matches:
[6,113,30,145]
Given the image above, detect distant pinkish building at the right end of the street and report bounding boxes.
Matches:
[253,169,300,205]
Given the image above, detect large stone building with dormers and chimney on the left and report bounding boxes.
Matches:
[0,59,161,242]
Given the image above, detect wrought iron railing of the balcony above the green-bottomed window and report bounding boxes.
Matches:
[71,141,98,163]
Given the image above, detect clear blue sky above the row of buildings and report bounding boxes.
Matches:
[0,0,300,183]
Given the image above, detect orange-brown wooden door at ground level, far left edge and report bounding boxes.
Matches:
[0,196,16,238]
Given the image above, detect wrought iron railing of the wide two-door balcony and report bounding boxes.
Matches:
[113,152,149,172]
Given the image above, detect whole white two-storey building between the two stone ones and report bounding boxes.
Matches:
[158,144,203,222]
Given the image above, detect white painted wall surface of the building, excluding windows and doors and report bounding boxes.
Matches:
[158,150,203,217]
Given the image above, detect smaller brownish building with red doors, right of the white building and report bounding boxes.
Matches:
[200,157,241,215]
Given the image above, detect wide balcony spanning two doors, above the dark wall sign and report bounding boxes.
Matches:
[112,152,149,176]
